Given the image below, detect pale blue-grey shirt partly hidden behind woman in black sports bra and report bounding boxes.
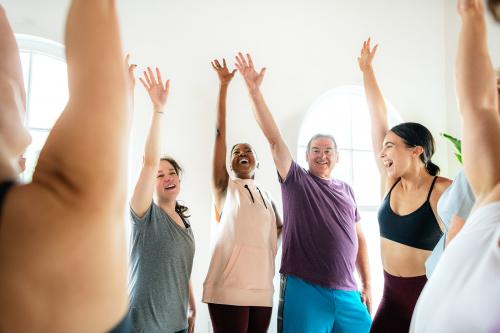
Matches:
[425,169,476,278]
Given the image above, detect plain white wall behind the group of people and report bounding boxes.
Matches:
[3,0,484,332]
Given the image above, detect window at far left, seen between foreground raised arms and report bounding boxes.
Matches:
[16,34,68,182]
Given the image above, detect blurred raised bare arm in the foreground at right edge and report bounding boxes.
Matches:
[456,0,500,205]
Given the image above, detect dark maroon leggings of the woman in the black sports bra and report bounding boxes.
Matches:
[370,271,427,333]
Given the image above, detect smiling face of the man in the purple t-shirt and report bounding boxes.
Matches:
[306,137,339,179]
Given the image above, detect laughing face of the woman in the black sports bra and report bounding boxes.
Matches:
[379,131,423,178]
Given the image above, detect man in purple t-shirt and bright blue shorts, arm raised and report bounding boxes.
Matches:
[236,53,371,333]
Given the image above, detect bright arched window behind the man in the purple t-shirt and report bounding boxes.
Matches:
[297,86,402,310]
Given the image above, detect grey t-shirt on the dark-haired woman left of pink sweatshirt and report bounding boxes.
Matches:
[130,202,195,333]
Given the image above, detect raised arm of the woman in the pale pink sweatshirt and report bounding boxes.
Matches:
[212,59,236,213]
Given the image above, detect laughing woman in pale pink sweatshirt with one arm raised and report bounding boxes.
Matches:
[203,60,282,333]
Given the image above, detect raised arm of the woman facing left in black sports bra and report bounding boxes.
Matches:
[358,38,389,184]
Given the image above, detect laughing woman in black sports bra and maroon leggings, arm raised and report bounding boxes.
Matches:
[358,39,451,332]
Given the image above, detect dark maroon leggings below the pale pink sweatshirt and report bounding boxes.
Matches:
[208,303,273,333]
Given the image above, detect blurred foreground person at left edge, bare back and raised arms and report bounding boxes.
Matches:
[0,0,130,333]
